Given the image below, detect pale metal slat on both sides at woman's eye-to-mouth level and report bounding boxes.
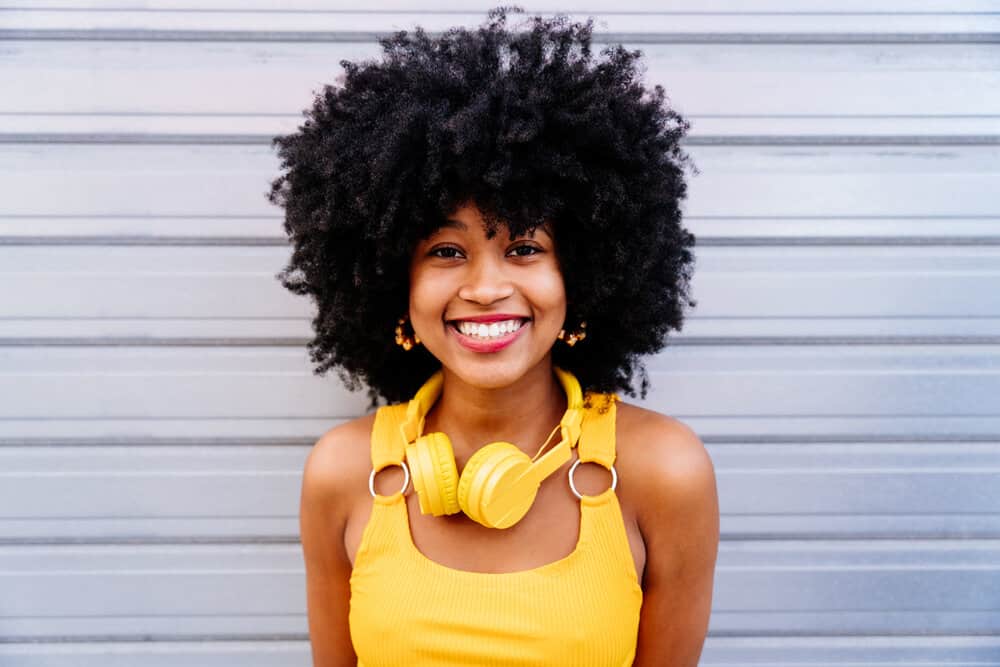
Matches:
[0,245,1000,324]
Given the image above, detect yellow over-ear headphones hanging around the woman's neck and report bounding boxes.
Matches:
[400,368,583,528]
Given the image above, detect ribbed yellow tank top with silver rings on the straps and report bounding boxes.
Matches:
[349,395,642,667]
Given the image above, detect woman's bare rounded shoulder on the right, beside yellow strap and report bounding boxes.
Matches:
[615,402,716,520]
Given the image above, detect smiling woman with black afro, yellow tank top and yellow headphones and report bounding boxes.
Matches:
[271,9,719,667]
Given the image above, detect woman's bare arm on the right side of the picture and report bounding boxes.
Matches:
[633,418,719,667]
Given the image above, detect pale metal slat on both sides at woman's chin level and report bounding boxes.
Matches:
[0,345,1000,418]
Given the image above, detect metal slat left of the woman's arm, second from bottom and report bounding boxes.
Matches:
[0,544,306,641]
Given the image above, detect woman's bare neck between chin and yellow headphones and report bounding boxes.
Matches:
[424,362,566,465]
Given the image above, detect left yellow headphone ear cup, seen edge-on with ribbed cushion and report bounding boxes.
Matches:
[406,433,459,516]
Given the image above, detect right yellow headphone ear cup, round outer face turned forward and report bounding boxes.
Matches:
[458,442,537,528]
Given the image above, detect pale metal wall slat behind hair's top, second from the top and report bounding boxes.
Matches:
[0,43,1000,143]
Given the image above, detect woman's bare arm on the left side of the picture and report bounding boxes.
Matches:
[299,423,367,667]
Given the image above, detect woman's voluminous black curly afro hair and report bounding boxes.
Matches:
[268,6,697,407]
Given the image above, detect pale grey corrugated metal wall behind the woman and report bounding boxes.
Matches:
[0,0,1000,667]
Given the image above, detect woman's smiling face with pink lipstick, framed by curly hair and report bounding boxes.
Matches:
[410,205,566,388]
